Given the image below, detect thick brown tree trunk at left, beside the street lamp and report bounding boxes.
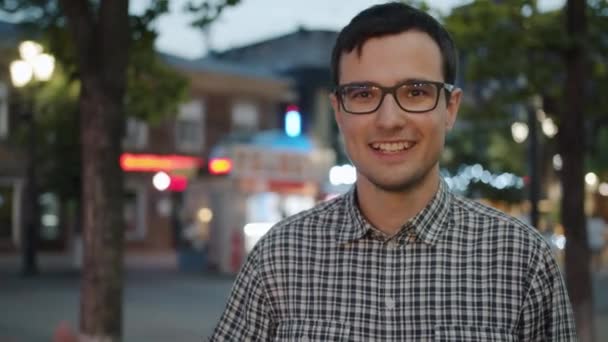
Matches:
[61,0,130,342]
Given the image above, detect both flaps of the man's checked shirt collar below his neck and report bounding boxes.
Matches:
[336,179,452,245]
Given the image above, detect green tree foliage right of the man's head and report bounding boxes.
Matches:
[441,0,608,199]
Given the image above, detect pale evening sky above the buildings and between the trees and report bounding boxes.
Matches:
[131,0,564,58]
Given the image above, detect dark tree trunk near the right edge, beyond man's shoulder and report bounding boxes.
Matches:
[559,0,594,342]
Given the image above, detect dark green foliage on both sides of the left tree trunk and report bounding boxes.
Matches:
[0,0,188,198]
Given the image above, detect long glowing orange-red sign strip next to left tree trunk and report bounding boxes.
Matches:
[120,153,203,172]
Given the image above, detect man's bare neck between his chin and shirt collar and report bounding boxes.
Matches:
[356,170,439,236]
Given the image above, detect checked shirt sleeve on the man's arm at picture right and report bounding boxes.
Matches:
[520,246,578,341]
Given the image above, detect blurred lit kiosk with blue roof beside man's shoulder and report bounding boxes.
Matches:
[185,131,334,273]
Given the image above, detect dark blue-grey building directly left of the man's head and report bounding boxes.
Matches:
[208,28,347,163]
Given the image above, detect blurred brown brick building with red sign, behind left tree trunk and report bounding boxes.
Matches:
[0,23,295,253]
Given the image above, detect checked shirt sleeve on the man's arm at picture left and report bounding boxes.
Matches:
[210,243,275,342]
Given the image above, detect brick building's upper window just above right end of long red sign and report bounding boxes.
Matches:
[175,101,205,153]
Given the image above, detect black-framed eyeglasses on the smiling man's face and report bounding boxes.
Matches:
[334,81,456,114]
